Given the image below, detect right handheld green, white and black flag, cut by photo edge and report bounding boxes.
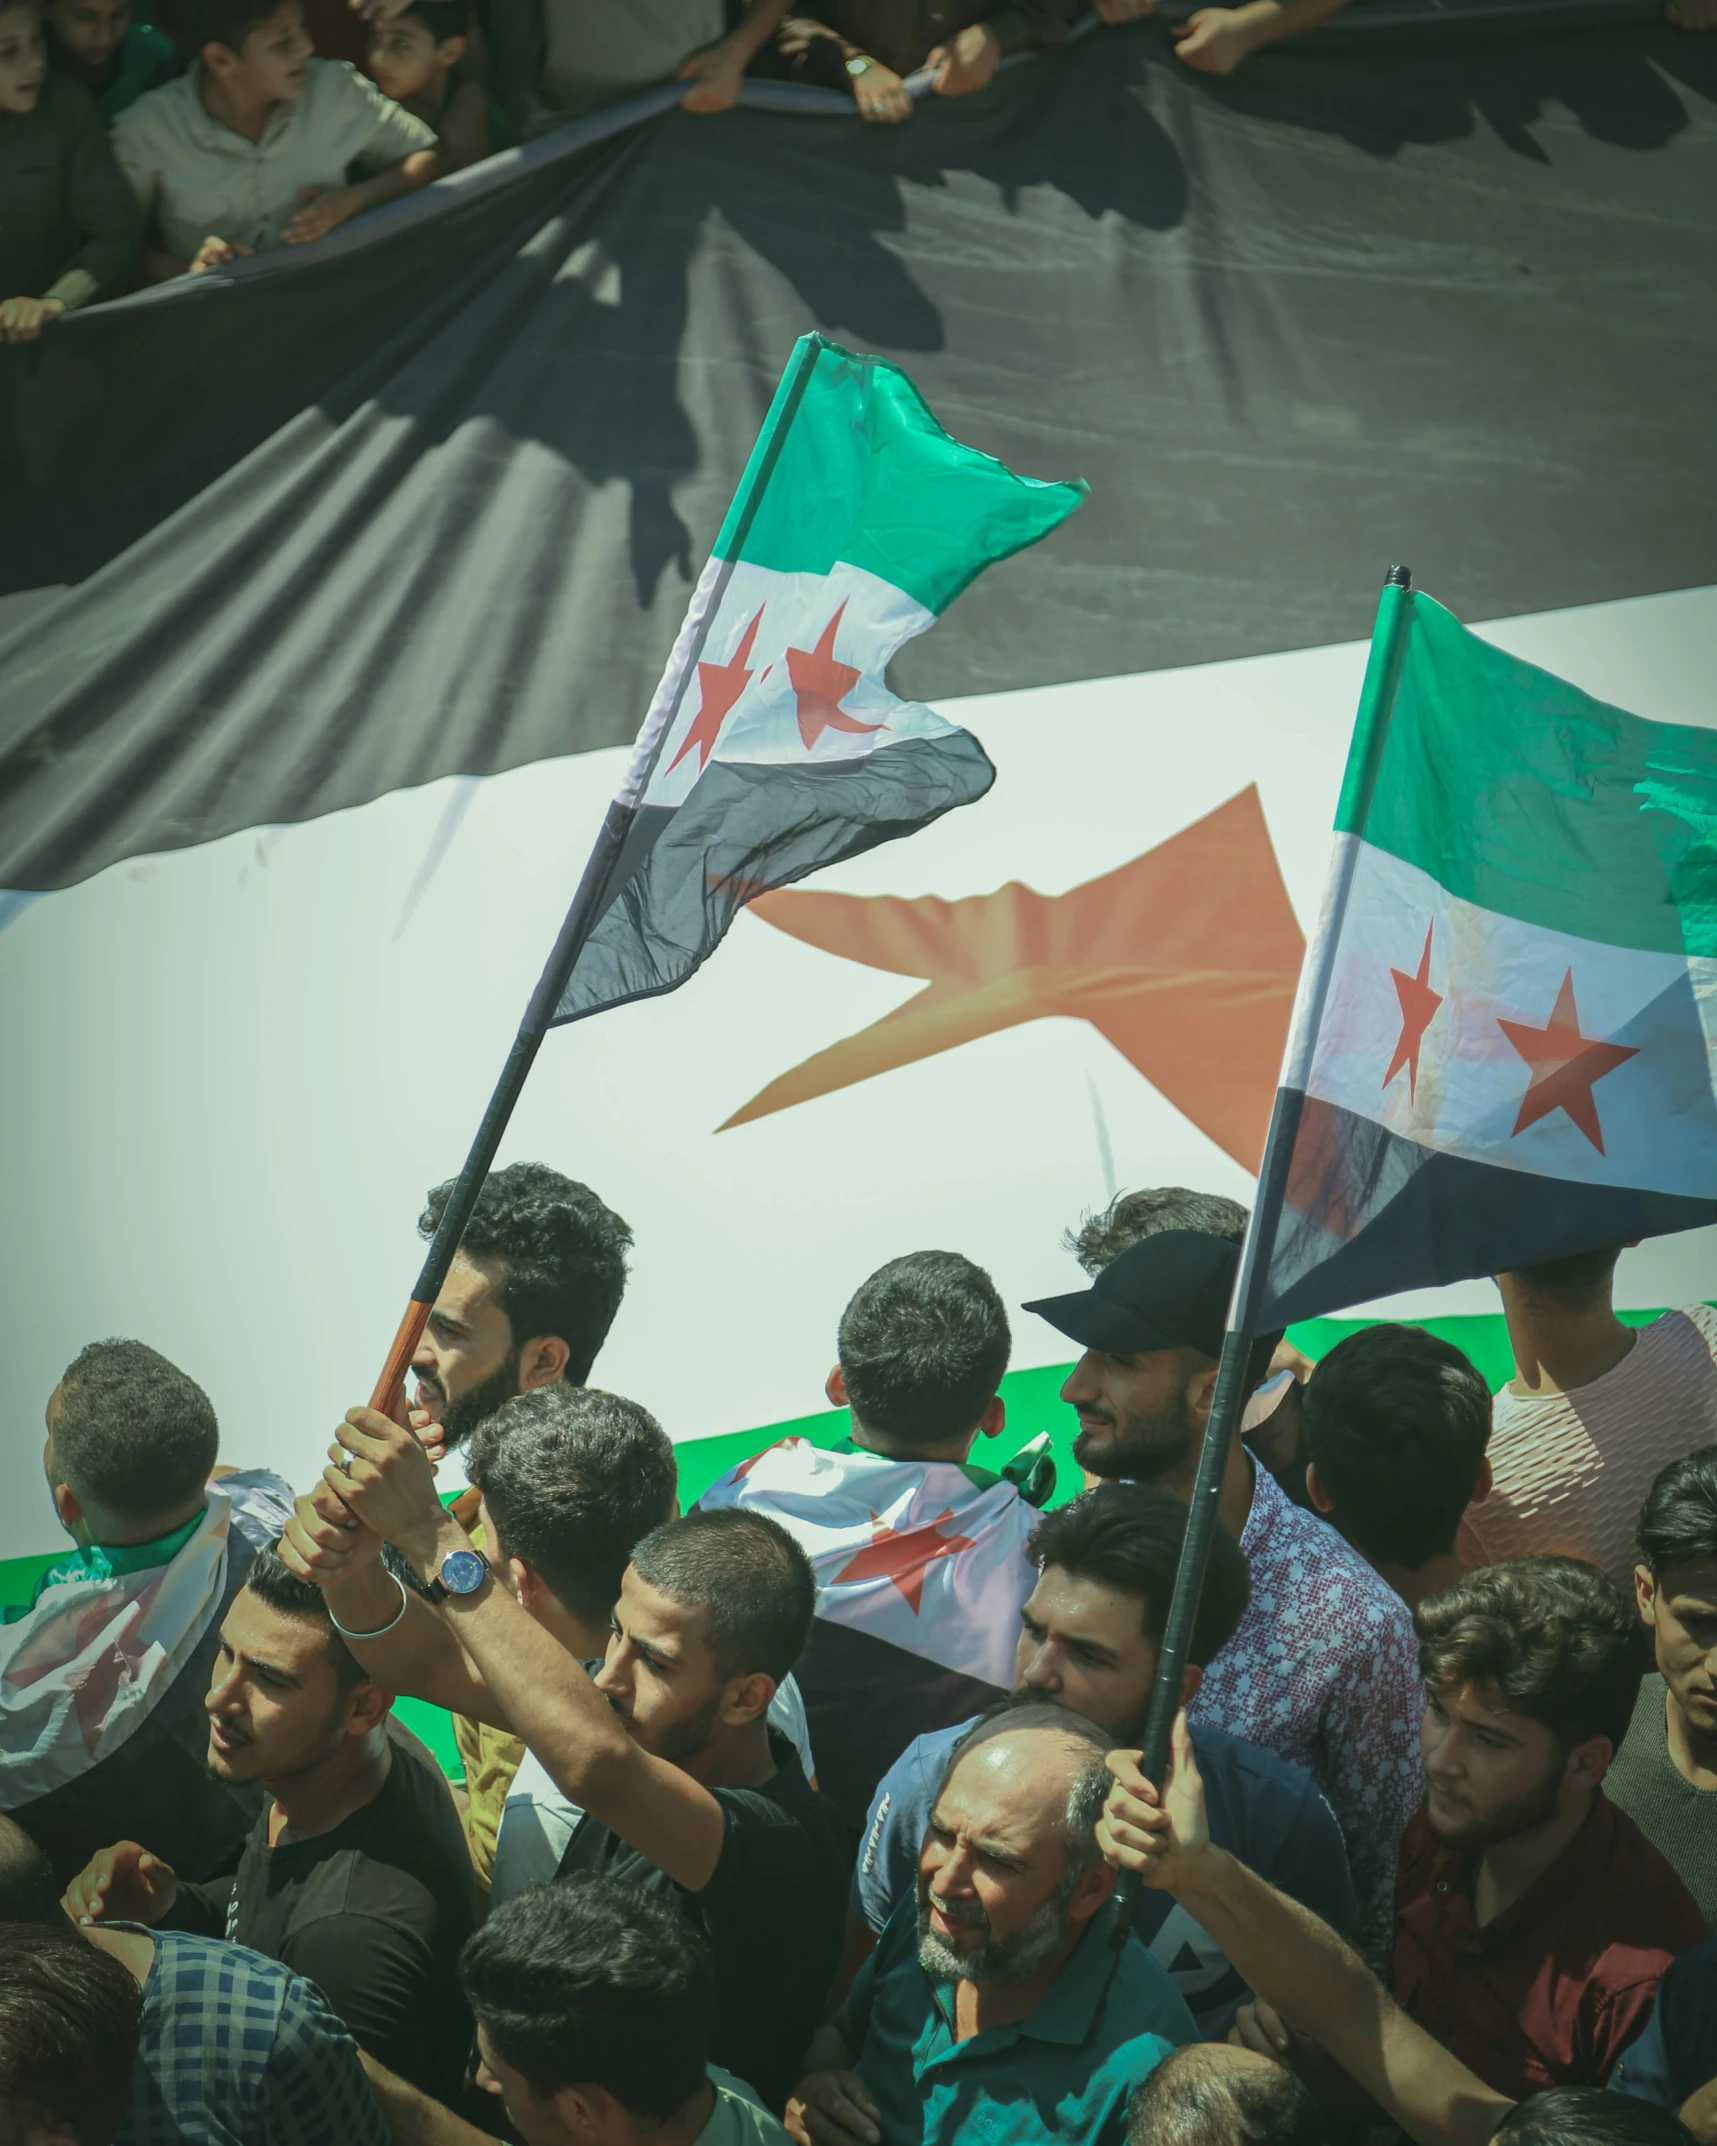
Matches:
[1249,586,1717,1331]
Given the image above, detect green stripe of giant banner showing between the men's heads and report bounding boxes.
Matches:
[0,1311,1691,1781]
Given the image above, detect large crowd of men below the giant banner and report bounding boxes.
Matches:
[0,1163,1717,2146]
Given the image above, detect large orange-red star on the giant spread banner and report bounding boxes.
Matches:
[721,788,1305,1172]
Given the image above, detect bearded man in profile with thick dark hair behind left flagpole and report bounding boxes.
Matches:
[410,1163,635,1888]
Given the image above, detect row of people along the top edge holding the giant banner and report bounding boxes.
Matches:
[0,0,1717,341]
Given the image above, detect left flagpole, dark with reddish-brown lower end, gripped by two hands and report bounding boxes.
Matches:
[358,335,826,1416]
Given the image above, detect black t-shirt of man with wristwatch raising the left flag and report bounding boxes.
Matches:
[560,1730,852,2110]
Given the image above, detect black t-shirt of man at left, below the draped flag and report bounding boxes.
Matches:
[170,1747,476,2101]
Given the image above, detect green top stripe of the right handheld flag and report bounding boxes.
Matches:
[1337,592,1717,955]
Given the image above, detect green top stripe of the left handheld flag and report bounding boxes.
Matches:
[715,335,1086,614]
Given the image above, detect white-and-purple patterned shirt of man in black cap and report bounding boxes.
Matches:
[1189,1468,1425,1968]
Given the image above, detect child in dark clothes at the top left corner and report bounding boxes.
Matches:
[0,0,142,343]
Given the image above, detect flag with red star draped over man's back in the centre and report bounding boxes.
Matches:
[700,1438,1037,1824]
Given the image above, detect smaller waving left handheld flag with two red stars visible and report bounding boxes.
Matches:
[554,335,1084,1021]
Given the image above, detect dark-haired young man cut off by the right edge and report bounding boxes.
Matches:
[1603,1446,1717,1925]
